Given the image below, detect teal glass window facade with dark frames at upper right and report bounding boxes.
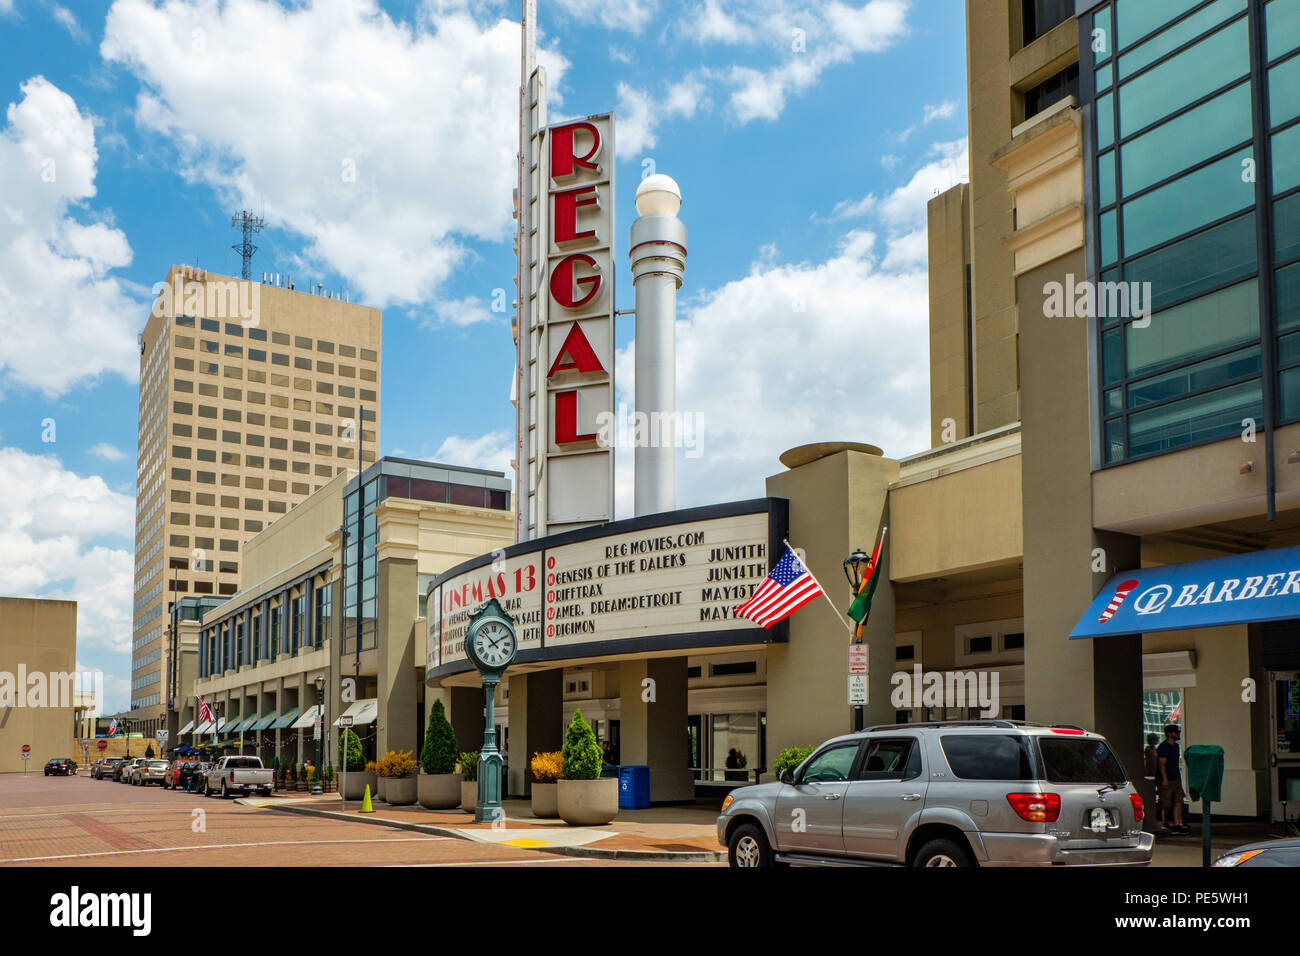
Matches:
[1079,0,1300,467]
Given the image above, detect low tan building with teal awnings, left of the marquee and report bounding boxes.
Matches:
[189,458,514,763]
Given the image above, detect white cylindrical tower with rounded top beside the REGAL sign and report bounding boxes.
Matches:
[628,174,686,515]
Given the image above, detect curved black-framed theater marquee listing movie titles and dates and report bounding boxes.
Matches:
[425,498,788,676]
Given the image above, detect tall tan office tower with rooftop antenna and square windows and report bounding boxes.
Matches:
[131,265,382,736]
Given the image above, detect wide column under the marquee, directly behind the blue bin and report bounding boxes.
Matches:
[619,657,696,804]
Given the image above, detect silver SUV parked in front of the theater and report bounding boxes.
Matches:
[718,721,1154,866]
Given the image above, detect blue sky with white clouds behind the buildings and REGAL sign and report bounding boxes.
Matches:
[0,0,969,711]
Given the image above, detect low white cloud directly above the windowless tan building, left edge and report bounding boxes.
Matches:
[0,447,135,652]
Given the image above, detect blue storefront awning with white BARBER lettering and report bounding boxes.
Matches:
[1070,548,1300,639]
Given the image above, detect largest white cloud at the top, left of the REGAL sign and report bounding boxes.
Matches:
[101,0,567,307]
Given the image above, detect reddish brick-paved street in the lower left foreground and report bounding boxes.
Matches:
[0,774,691,868]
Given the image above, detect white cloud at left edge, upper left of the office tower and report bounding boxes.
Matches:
[0,77,144,397]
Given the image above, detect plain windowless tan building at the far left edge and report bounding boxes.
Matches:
[0,597,85,774]
